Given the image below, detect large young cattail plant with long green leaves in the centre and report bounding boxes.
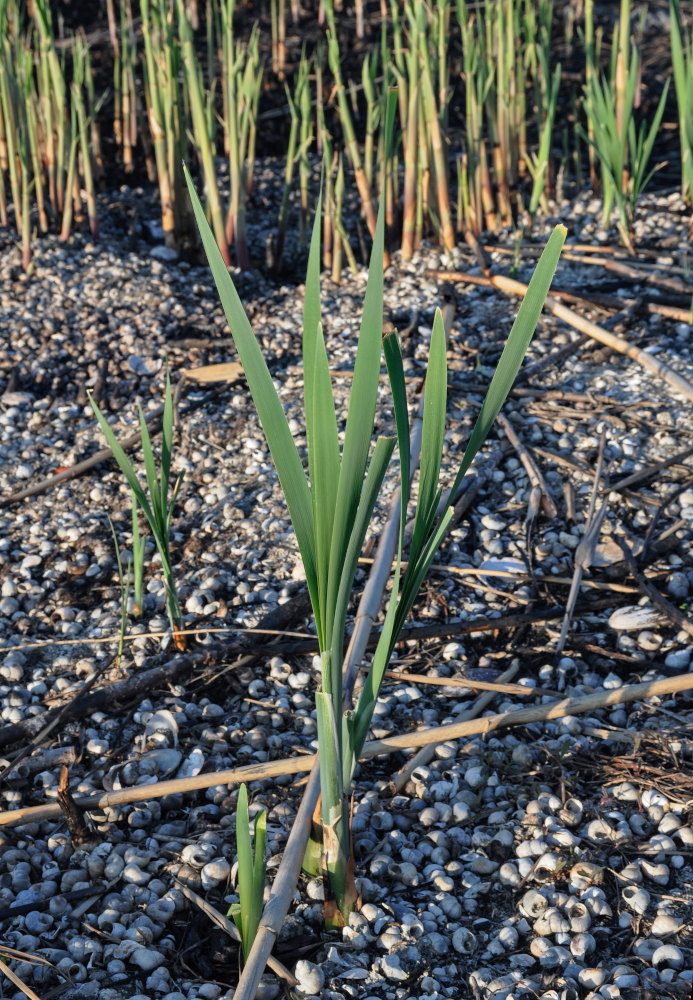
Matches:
[188,90,565,926]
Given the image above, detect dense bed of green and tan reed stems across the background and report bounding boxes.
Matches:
[0,0,693,272]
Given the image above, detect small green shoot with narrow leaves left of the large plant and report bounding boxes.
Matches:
[89,374,185,649]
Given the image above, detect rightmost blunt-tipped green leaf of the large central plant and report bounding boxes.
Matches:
[450,226,567,496]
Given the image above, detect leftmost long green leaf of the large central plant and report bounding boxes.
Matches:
[184,168,319,608]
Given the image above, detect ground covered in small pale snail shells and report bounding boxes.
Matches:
[0,180,693,1000]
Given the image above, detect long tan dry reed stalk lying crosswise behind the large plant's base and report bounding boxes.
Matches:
[6,673,693,828]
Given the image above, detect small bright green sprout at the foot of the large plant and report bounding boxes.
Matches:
[228,784,267,959]
